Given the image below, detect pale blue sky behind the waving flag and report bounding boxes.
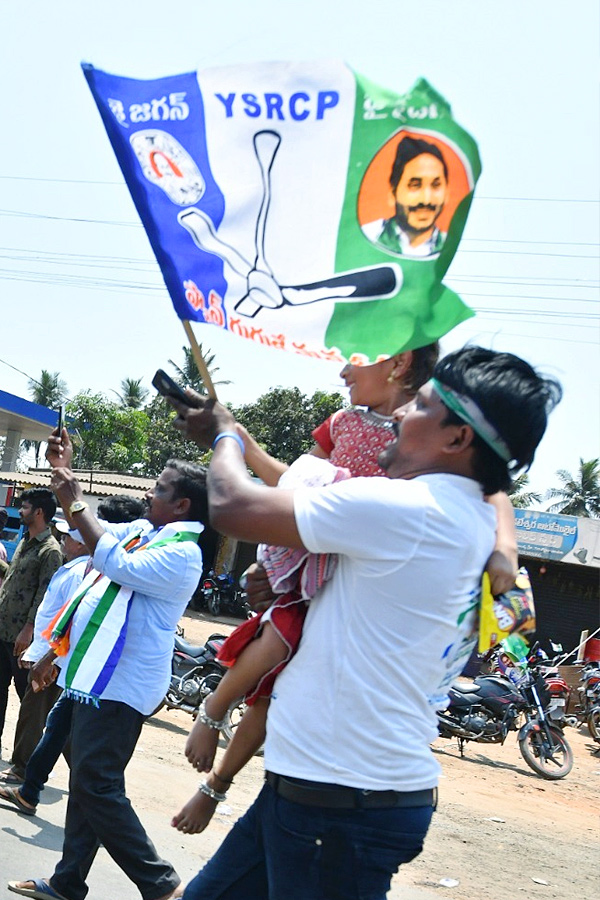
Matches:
[0,0,600,491]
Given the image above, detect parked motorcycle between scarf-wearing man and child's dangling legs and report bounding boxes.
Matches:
[159,634,227,718]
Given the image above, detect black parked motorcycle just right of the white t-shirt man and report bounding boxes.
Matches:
[437,669,573,780]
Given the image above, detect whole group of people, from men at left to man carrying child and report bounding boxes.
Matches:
[0,345,561,900]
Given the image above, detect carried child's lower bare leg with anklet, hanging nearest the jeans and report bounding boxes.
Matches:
[171,698,269,834]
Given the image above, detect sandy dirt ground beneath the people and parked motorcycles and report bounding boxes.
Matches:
[4,613,600,900]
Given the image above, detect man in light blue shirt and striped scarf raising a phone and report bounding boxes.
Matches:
[8,450,207,900]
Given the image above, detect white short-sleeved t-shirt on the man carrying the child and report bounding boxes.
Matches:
[265,474,496,791]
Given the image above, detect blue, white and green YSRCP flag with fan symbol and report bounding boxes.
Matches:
[83,61,481,363]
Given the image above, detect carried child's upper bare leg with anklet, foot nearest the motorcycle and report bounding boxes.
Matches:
[185,622,288,772]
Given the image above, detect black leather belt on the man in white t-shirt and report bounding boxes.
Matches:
[265,772,437,809]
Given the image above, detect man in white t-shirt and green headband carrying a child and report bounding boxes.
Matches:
[168,347,561,900]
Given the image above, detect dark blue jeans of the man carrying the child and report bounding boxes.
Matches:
[183,785,433,900]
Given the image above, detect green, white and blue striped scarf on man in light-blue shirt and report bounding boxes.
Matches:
[43,522,203,706]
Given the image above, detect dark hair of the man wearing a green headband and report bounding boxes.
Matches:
[433,347,562,494]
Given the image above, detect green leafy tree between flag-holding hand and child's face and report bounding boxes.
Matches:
[233,387,344,464]
